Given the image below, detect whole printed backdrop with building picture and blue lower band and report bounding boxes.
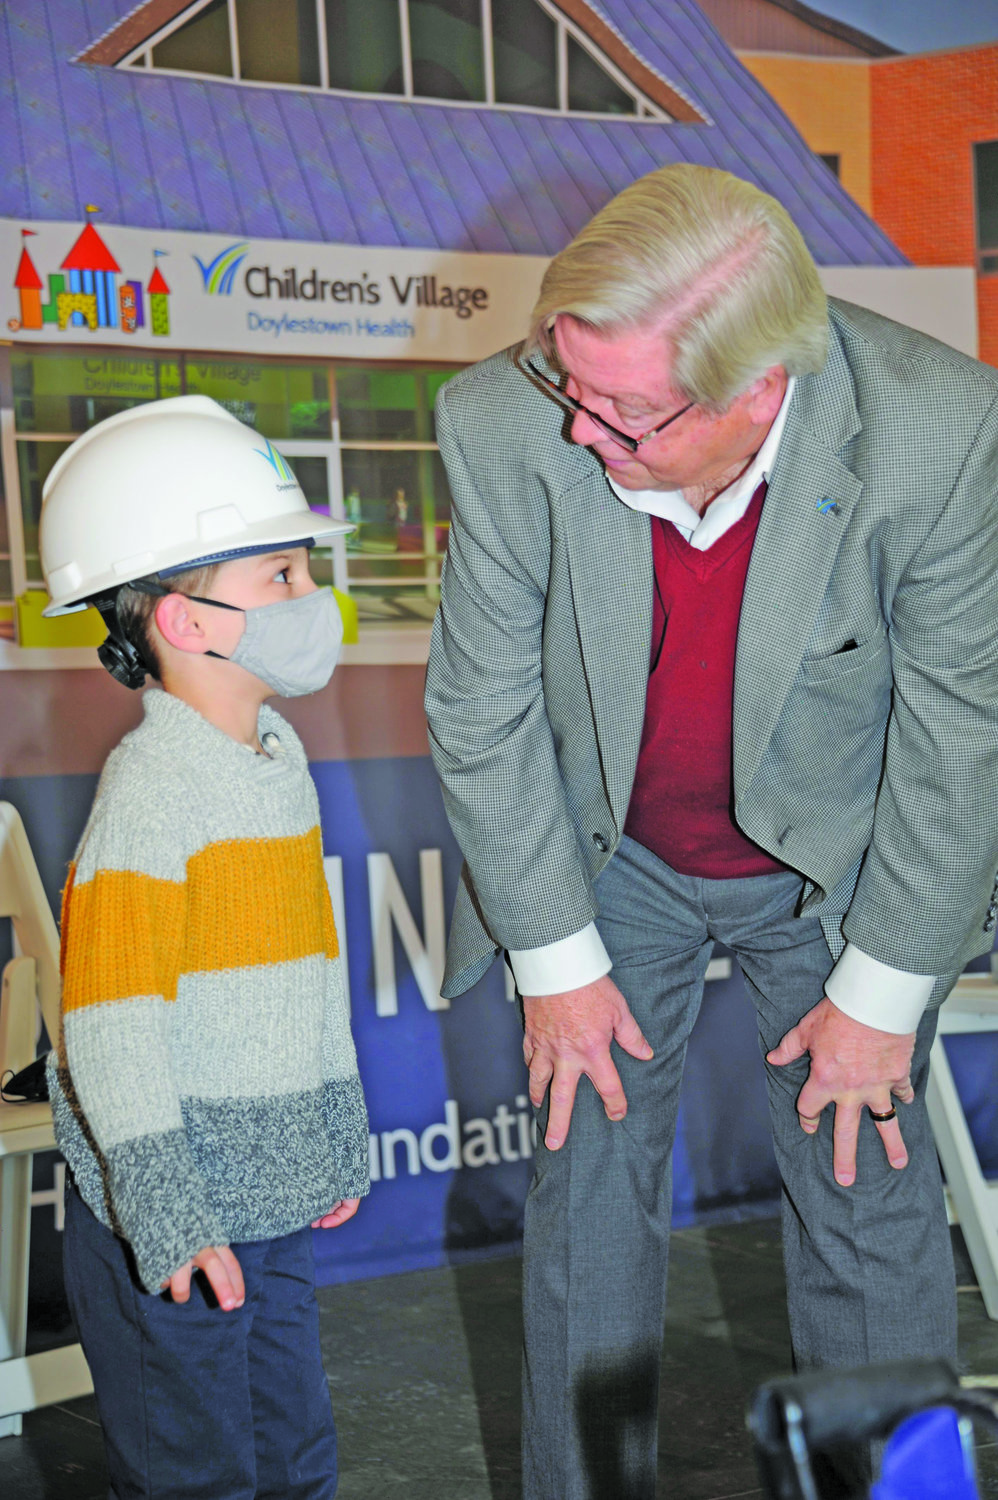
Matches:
[0,0,998,1343]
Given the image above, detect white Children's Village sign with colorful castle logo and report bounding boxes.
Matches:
[0,219,548,362]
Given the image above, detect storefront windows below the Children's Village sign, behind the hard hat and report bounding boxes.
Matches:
[0,350,453,633]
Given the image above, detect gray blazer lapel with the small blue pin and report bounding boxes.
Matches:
[734,330,863,801]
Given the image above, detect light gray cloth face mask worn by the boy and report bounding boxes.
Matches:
[225,588,344,698]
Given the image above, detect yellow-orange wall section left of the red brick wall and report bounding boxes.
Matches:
[738,53,873,213]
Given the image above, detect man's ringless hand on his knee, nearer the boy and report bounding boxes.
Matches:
[524,974,653,1151]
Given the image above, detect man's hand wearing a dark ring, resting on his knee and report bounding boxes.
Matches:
[765,996,915,1188]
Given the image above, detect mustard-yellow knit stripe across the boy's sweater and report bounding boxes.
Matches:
[63,828,339,1010]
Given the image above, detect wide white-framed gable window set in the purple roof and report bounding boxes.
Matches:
[122,0,668,120]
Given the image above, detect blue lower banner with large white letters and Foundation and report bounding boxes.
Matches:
[7,735,998,1314]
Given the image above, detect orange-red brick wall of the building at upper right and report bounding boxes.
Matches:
[870,44,998,365]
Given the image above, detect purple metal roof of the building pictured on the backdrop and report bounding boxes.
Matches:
[0,0,906,266]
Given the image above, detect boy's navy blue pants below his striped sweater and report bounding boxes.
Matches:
[65,1188,336,1500]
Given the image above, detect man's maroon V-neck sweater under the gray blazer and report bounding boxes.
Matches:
[624,482,786,881]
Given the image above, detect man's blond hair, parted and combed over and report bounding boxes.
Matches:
[527,164,828,411]
